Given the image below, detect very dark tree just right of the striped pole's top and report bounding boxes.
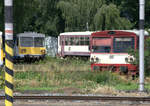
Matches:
[13,0,37,33]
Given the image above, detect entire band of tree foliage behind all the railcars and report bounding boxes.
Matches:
[0,0,150,36]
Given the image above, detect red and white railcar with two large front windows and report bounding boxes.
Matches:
[90,30,148,75]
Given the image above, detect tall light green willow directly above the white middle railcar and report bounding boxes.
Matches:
[57,0,104,31]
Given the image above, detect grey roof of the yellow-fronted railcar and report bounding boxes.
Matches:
[17,32,45,37]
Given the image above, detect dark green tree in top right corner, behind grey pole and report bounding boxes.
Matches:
[120,0,150,28]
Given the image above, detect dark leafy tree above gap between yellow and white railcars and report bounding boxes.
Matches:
[21,0,63,36]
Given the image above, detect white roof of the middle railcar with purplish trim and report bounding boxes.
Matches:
[59,31,93,36]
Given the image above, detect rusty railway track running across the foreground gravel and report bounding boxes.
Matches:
[0,96,150,102]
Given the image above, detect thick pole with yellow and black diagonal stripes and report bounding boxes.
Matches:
[4,0,14,106]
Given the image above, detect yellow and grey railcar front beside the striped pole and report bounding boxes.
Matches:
[14,32,46,60]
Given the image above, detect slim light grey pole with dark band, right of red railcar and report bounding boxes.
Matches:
[139,0,145,92]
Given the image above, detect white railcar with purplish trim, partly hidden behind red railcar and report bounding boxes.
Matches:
[58,31,92,57]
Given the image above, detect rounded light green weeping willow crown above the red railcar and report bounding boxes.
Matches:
[94,4,132,30]
